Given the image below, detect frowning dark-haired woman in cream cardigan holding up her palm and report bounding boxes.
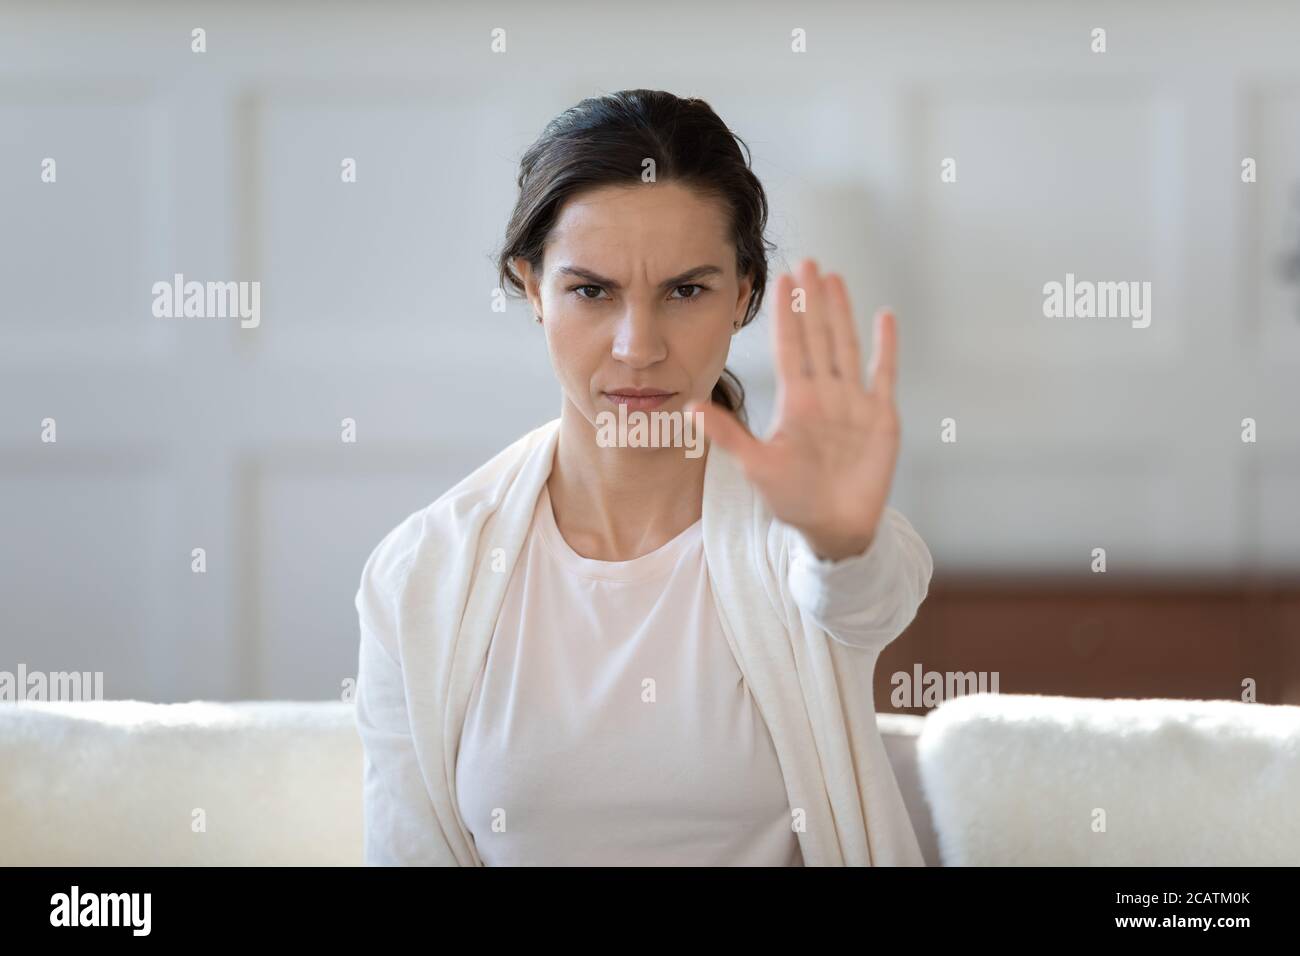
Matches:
[356,90,932,865]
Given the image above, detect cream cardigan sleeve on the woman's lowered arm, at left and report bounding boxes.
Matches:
[354,525,456,866]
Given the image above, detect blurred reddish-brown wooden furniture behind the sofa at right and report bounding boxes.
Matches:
[875,572,1300,714]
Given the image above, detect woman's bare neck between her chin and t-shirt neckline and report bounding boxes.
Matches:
[546,399,709,561]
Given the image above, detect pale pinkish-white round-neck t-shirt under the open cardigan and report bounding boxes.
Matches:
[456,485,803,866]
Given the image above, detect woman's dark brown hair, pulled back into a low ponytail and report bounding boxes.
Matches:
[497,90,775,424]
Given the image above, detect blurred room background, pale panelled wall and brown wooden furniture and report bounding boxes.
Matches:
[0,3,1300,713]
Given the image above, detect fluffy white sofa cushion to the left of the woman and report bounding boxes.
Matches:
[0,701,361,866]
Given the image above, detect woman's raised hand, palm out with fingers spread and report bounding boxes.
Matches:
[686,259,900,561]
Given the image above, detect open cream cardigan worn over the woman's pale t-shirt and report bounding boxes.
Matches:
[355,419,933,866]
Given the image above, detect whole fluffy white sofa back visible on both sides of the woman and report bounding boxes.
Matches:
[0,695,1300,865]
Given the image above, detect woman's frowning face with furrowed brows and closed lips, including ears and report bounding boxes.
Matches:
[515,182,751,427]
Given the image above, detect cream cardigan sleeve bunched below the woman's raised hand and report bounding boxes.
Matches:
[789,506,935,652]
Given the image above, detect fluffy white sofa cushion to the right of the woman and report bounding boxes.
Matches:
[918,693,1300,866]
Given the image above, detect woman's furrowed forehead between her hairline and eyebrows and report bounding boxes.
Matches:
[546,183,735,274]
